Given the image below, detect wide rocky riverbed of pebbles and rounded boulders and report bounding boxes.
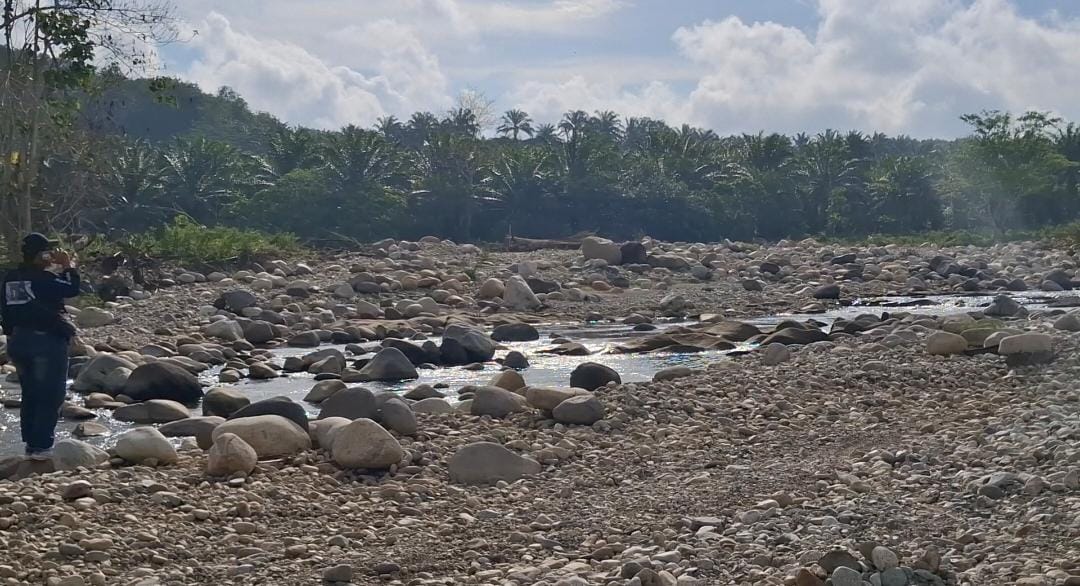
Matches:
[0,236,1080,586]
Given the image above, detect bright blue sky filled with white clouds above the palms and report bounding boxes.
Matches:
[158,0,1080,138]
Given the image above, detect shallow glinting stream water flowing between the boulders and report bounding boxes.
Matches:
[0,291,1076,456]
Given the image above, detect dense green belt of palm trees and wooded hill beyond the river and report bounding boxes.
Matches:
[31,72,1080,241]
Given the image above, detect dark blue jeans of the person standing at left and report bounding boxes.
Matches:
[8,328,69,452]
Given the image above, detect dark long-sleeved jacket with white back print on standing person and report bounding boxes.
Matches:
[0,265,80,338]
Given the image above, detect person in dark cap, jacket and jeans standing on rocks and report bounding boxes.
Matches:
[0,233,80,460]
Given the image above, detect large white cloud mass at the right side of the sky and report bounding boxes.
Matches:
[673,0,1080,136]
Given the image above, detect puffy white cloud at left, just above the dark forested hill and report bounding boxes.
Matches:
[184,13,448,128]
